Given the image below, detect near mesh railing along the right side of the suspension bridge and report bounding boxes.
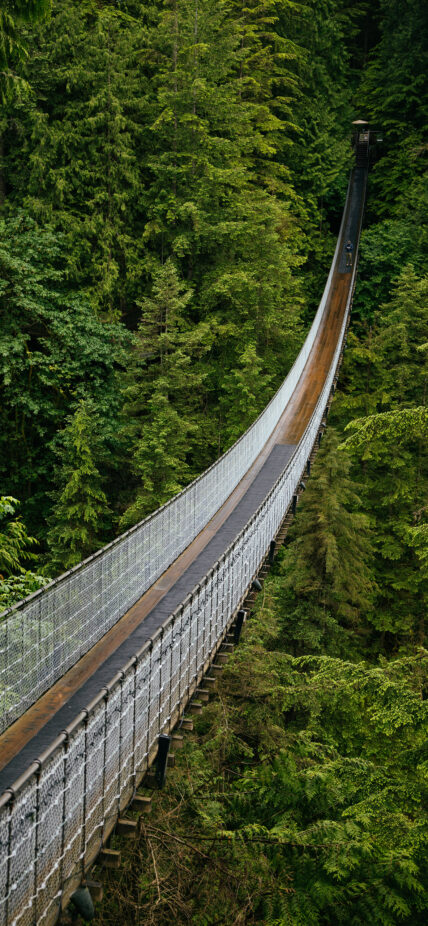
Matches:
[0,169,368,926]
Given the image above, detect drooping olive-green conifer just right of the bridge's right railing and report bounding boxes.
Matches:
[282,429,375,652]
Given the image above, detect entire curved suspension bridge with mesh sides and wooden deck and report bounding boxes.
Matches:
[0,165,367,926]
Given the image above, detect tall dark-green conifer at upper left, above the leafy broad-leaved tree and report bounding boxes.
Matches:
[5,0,146,319]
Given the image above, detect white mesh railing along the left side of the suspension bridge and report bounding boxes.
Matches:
[0,181,351,733]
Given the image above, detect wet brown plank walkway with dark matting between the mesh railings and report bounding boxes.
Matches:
[0,169,364,793]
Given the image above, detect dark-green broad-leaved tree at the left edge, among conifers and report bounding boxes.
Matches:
[0,212,126,537]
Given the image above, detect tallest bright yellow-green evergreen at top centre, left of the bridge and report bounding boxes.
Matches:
[146,0,302,449]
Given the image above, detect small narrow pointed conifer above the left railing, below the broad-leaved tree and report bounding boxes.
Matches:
[48,400,110,570]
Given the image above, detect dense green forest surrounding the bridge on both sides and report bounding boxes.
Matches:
[0,0,428,926]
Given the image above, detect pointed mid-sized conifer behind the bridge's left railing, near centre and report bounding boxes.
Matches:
[121,260,210,527]
